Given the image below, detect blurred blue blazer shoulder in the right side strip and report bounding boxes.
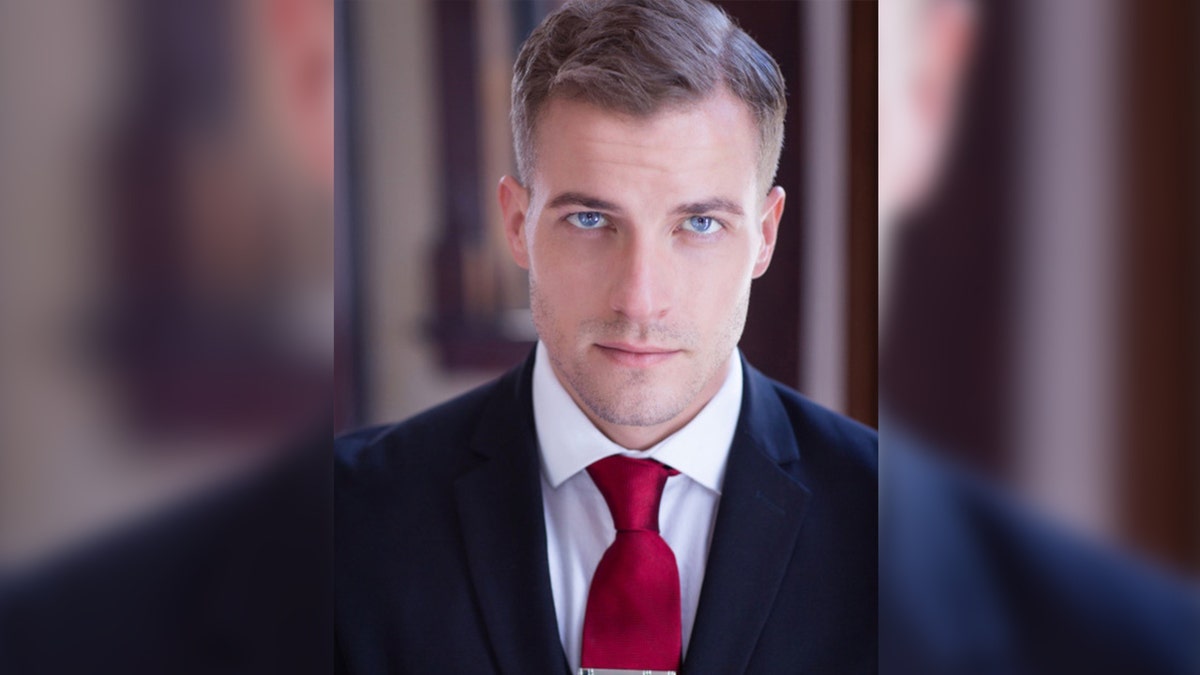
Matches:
[880,416,1200,675]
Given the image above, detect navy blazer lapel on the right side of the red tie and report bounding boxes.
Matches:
[684,360,809,675]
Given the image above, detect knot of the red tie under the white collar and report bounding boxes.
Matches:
[588,455,679,532]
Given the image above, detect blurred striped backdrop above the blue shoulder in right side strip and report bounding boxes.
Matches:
[880,0,1200,577]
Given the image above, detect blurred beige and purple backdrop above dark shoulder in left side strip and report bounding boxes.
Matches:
[0,0,334,572]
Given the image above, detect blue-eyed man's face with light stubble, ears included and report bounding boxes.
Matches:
[500,92,784,447]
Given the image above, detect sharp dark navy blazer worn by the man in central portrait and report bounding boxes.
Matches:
[335,356,877,675]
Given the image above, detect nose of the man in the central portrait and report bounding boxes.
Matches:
[610,235,674,323]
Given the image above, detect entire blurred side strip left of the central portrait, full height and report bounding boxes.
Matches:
[0,0,334,675]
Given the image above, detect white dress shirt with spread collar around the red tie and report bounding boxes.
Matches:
[533,342,742,673]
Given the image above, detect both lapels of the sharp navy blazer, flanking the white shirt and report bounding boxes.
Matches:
[455,354,810,675]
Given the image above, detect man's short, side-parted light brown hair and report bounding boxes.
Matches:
[512,0,787,185]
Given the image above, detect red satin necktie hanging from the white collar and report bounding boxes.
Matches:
[582,455,683,670]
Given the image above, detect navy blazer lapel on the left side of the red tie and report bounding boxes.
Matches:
[455,357,568,675]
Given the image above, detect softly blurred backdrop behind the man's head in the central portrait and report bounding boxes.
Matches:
[335,0,877,430]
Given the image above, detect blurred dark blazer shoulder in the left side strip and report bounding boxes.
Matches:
[0,424,334,675]
